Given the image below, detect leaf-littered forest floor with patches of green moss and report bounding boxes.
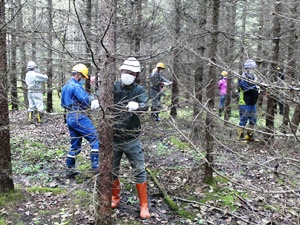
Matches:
[0,111,300,225]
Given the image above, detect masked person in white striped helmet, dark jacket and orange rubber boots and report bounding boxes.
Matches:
[111,57,150,219]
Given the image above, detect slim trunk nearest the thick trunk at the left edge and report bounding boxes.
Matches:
[9,0,19,110]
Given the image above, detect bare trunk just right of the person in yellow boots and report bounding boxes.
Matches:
[266,1,282,141]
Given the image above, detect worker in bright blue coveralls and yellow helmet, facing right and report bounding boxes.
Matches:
[61,63,99,178]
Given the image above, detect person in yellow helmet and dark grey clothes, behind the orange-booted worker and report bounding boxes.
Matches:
[149,62,172,121]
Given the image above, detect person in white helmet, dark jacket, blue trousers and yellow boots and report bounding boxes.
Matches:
[238,59,259,141]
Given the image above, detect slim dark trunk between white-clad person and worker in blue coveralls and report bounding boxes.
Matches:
[46,0,53,112]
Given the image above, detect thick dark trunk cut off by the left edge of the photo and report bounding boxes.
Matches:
[0,0,14,193]
